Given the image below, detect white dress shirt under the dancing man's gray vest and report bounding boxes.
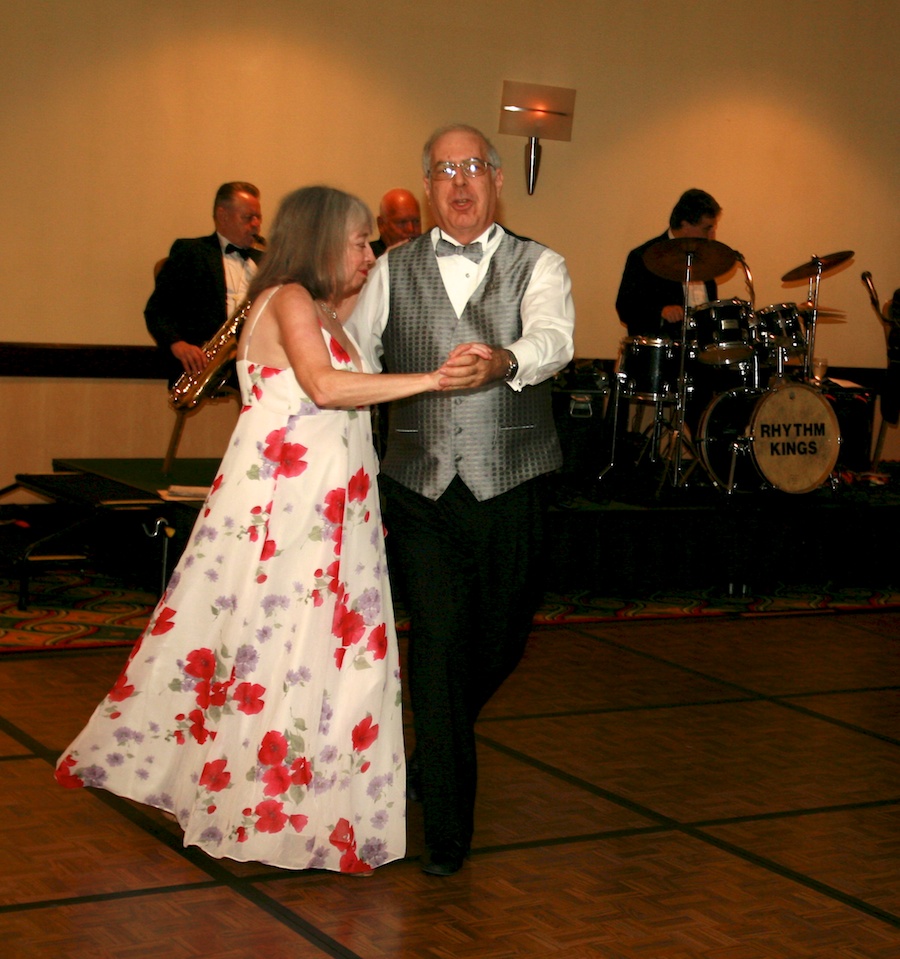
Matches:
[347,224,575,391]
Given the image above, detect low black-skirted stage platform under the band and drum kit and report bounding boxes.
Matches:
[0,459,900,595]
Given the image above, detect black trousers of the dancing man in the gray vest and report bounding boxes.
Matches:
[380,477,546,848]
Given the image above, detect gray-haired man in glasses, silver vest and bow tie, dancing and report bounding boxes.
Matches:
[350,126,574,876]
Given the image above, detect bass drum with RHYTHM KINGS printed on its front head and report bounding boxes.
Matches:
[697,383,841,493]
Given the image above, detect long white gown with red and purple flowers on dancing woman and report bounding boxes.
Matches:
[56,296,406,872]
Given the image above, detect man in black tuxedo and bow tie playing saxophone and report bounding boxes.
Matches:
[144,181,262,386]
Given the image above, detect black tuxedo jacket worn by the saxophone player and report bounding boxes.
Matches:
[144,233,262,381]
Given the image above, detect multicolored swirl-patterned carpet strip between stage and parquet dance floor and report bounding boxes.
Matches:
[0,570,900,653]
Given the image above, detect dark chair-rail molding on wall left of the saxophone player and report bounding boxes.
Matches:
[0,343,167,380]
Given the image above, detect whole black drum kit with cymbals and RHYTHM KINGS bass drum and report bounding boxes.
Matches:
[600,237,853,493]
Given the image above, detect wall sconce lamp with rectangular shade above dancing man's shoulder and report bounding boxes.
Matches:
[500,80,575,196]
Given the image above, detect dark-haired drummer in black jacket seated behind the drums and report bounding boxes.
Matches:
[616,189,722,340]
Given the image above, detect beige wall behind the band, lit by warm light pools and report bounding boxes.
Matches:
[0,0,900,492]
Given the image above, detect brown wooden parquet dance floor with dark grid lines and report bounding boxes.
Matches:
[0,612,900,959]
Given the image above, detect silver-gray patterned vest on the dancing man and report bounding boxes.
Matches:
[382,233,562,500]
